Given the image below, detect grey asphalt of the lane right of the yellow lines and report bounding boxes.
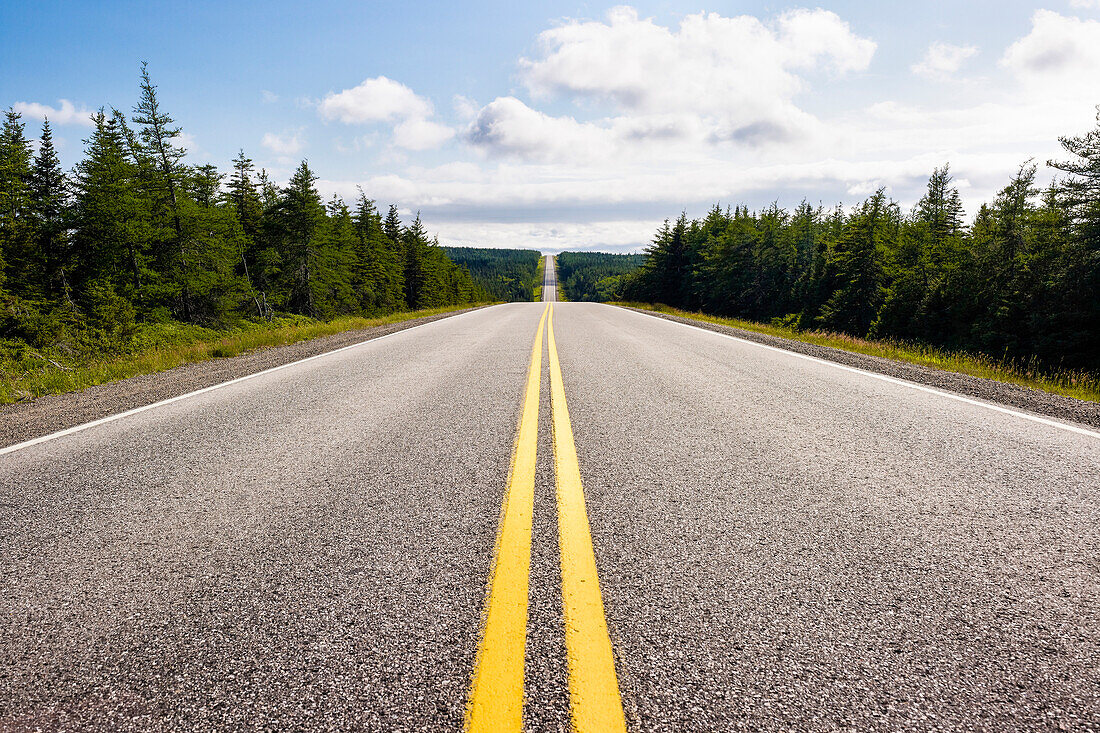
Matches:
[554,304,1100,731]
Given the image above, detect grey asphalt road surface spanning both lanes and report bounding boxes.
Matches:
[0,294,1100,731]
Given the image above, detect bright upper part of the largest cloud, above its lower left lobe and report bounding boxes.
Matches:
[520,7,876,128]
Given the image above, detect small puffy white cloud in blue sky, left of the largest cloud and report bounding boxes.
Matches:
[318,76,454,150]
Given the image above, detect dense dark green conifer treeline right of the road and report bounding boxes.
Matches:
[623,118,1100,371]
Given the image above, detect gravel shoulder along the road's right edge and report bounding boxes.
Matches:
[620,306,1100,427]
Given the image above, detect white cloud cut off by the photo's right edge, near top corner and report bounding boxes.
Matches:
[1001,10,1100,94]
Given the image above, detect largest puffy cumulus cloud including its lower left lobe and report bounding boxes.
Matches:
[465,7,876,161]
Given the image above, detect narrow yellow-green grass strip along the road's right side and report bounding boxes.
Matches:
[613,303,1100,402]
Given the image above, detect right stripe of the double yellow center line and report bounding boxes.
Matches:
[547,305,626,733]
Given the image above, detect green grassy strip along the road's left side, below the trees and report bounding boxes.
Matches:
[0,304,484,404]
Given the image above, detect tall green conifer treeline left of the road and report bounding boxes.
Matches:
[0,65,485,349]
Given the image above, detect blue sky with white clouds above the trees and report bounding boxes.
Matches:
[0,0,1100,252]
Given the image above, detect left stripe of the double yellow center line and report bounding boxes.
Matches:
[466,305,550,733]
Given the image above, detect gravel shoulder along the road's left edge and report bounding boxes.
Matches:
[0,306,486,448]
